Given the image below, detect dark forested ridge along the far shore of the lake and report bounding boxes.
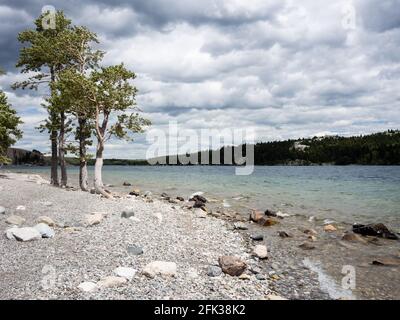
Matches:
[7,130,400,165]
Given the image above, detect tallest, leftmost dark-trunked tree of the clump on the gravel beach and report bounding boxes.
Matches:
[13,11,71,185]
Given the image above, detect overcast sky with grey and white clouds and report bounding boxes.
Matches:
[0,0,400,158]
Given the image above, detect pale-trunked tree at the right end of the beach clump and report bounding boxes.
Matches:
[86,64,151,197]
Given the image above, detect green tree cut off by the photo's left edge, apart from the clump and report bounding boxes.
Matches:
[0,70,22,164]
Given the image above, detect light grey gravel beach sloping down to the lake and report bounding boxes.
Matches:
[0,174,282,299]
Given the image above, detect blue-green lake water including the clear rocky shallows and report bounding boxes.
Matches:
[3,166,400,299]
